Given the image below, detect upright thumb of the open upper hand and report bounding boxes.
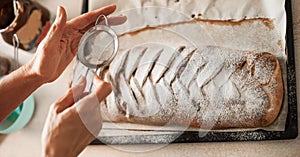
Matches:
[46,6,67,42]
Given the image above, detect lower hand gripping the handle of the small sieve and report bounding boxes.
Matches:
[42,78,111,157]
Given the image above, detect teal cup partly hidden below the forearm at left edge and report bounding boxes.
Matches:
[0,95,35,134]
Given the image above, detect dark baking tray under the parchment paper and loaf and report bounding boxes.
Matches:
[91,0,298,145]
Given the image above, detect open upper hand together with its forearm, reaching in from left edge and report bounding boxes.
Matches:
[0,5,126,122]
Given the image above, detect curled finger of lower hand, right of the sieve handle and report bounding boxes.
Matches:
[93,76,112,102]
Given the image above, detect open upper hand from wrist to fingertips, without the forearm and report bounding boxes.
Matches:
[27,5,126,82]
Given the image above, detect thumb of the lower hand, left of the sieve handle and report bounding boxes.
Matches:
[54,77,86,113]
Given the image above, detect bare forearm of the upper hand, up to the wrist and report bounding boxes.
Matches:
[0,63,44,121]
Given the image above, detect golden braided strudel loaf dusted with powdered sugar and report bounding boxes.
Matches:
[102,46,283,129]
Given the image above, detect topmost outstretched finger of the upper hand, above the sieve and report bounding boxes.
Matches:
[68,5,116,30]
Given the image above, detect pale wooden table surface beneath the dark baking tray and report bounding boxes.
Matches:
[0,0,300,157]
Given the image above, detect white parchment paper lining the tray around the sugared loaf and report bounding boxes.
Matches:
[89,0,288,136]
